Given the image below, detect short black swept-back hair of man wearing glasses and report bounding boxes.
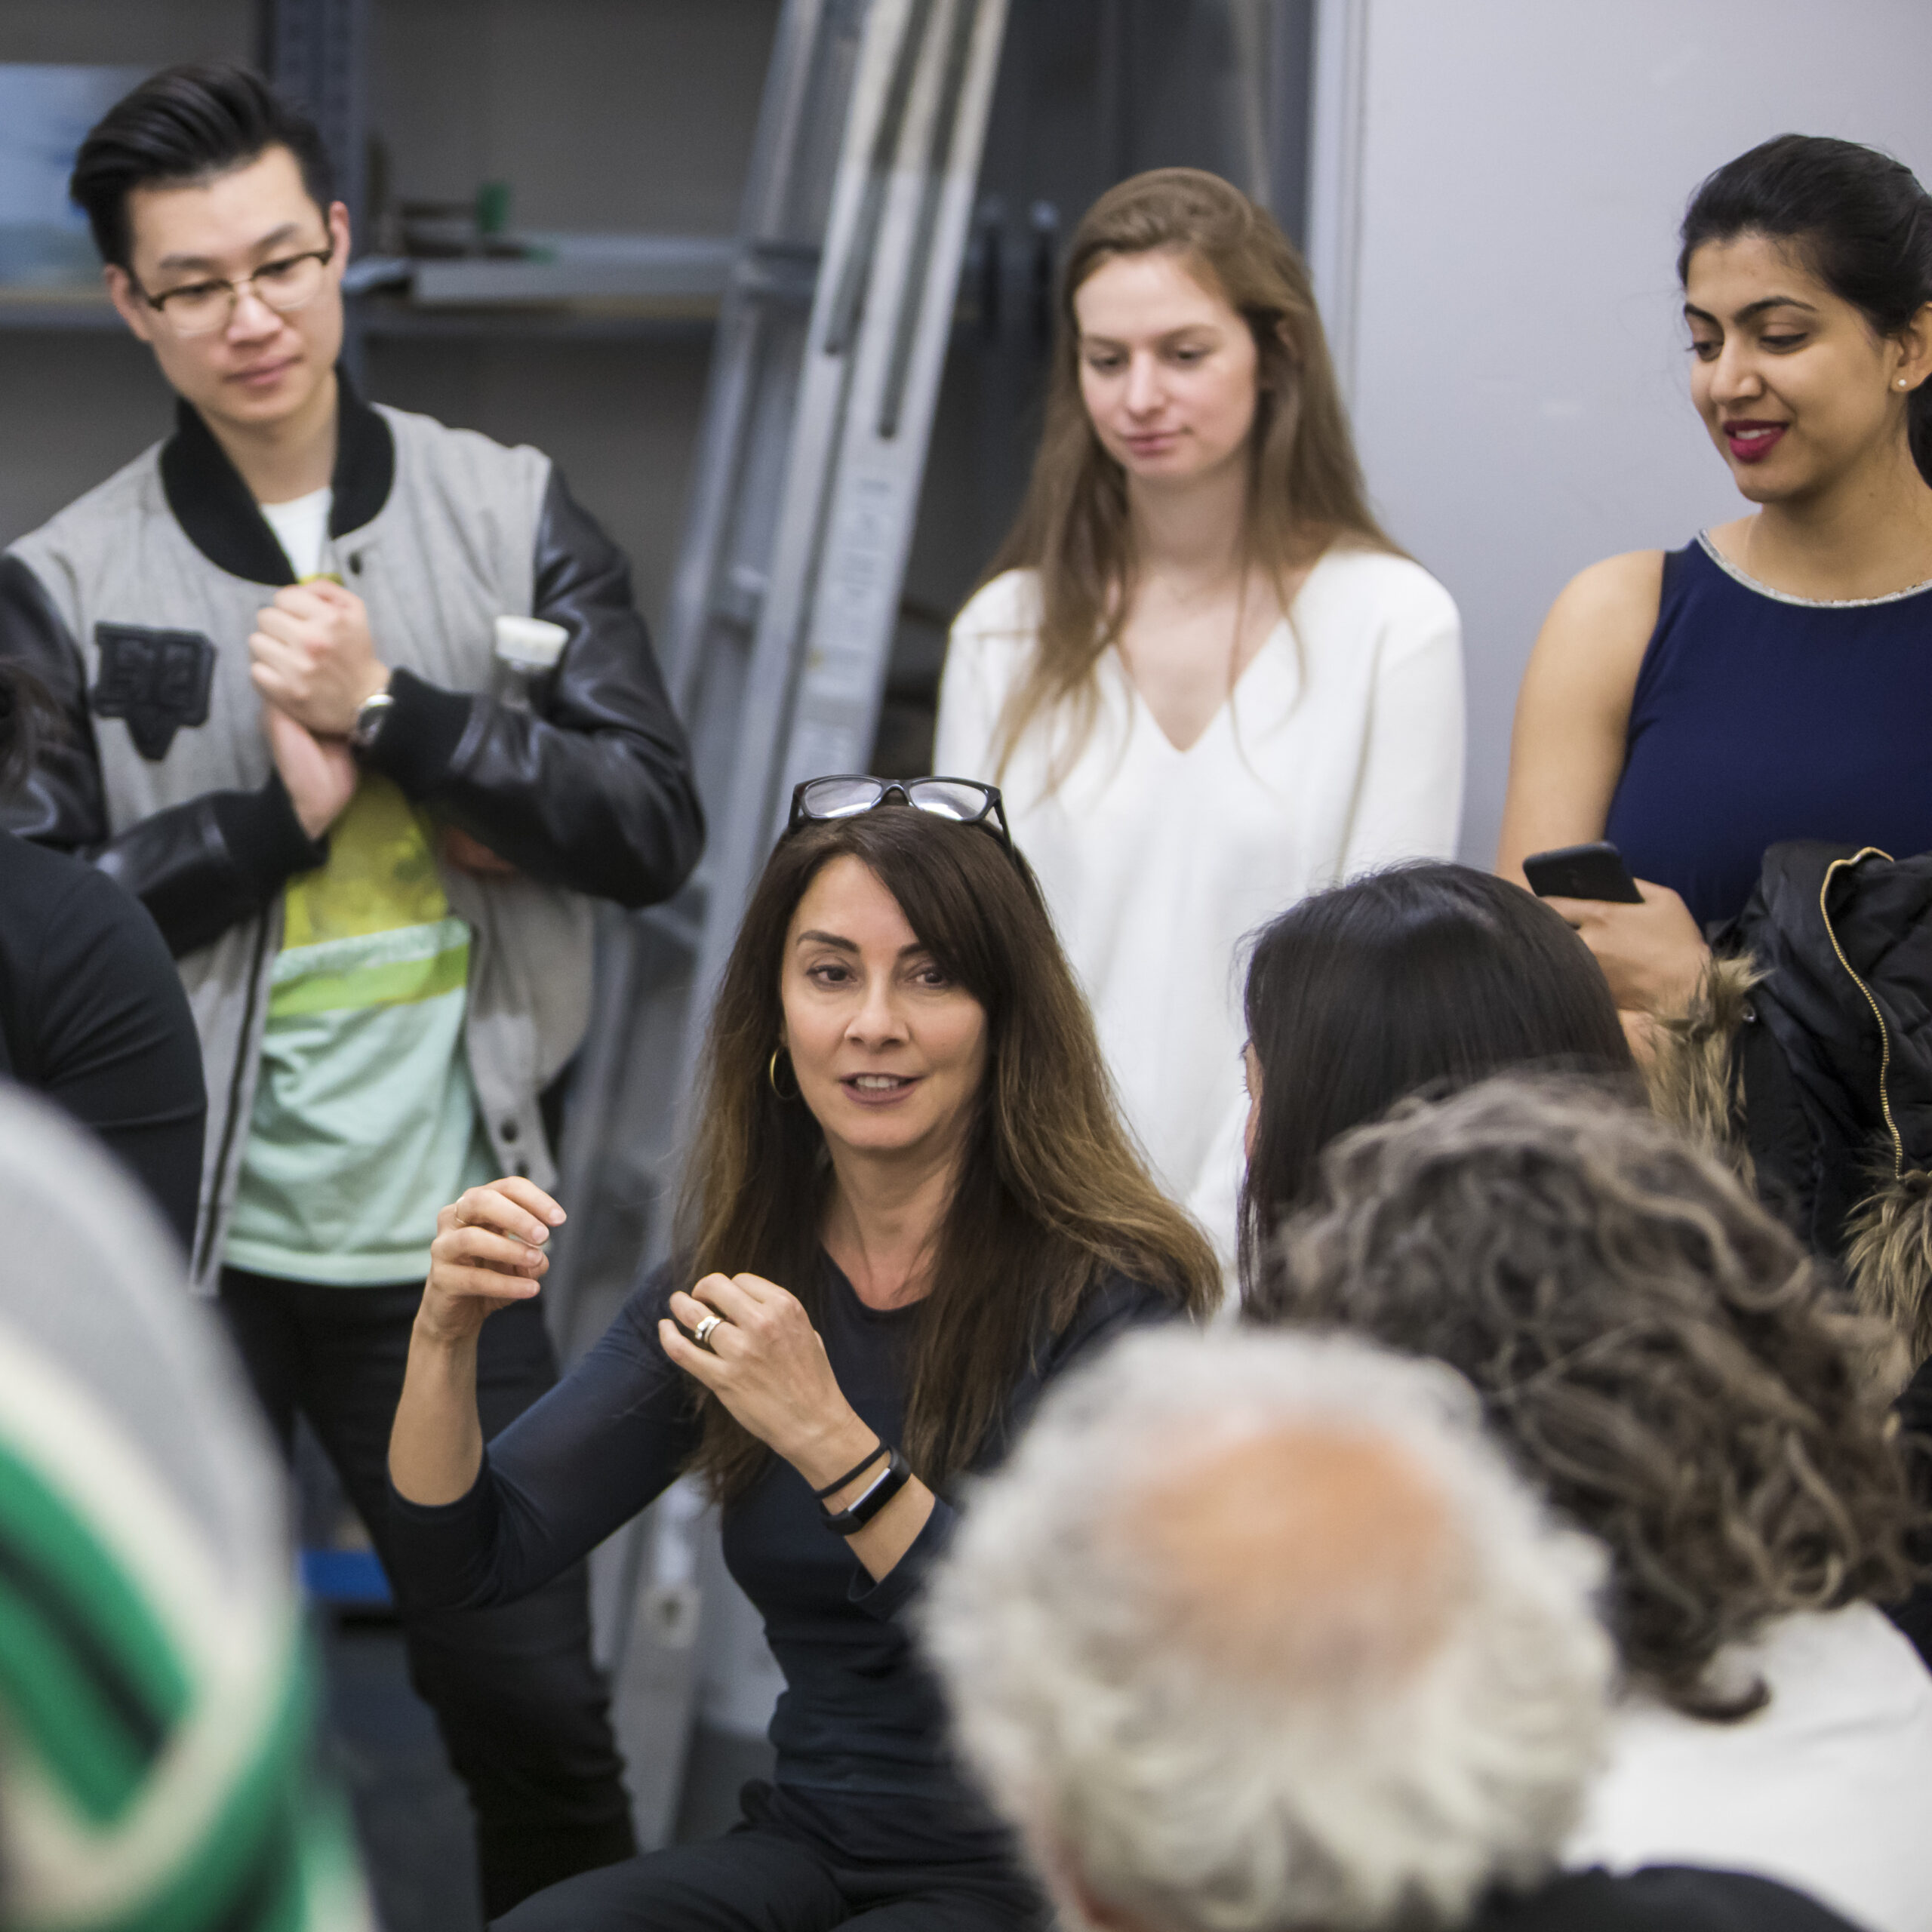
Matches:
[68,66,336,269]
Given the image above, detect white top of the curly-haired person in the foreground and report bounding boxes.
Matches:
[1563,1604,1932,1932]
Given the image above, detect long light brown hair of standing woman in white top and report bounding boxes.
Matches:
[981,168,1401,765]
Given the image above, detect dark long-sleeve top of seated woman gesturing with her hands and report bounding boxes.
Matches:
[392,1258,1173,1864]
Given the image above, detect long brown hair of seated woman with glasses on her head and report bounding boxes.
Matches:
[676,806,1221,1503]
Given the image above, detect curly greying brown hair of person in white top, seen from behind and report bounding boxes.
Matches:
[1246,1076,1917,1718]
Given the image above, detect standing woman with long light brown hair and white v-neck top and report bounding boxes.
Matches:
[935,168,1463,1262]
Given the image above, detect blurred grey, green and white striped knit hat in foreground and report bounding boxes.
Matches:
[0,1084,371,1932]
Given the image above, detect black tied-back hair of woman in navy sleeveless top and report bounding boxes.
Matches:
[1677,134,1932,481]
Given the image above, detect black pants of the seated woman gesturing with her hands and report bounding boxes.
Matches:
[491,1785,1049,1932]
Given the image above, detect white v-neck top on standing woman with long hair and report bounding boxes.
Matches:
[933,551,1463,1262]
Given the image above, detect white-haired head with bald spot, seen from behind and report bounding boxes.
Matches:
[928,1329,1614,1932]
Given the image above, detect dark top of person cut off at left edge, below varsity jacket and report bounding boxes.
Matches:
[0,831,207,1252]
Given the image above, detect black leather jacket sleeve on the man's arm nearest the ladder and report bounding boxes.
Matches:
[369,469,703,906]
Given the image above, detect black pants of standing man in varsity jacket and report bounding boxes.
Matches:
[222,1267,638,1918]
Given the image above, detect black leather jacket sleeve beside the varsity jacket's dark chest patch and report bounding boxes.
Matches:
[0,556,328,958]
